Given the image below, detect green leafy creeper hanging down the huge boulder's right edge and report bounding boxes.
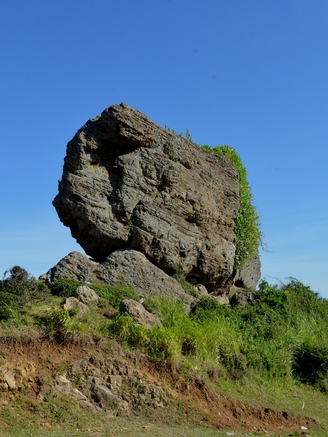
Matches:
[203,145,262,270]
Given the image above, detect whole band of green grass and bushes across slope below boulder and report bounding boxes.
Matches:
[0,262,328,392]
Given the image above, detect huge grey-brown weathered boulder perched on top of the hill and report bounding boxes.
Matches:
[53,103,243,292]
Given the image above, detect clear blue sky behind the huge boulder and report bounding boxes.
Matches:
[0,0,328,298]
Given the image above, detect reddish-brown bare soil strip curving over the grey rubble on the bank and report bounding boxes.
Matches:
[0,338,315,435]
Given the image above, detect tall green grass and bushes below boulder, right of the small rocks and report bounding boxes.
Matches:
[110,279,328,391]
